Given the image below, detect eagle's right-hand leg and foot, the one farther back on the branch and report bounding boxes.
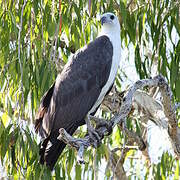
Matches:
[89,115,112,135]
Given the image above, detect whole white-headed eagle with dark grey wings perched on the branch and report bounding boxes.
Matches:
[35,12,121,170]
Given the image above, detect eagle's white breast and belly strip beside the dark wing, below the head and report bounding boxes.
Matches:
[88,33,121,114]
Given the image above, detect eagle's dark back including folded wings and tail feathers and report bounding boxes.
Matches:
[36,36,113,169]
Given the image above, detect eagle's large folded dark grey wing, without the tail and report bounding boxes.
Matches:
[43,36,113,134]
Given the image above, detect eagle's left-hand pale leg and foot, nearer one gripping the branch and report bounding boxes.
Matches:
[85,115,101,147]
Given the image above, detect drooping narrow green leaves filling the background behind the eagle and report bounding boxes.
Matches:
[0,0,180,179]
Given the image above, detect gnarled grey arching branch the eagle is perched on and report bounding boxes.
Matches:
[58,75,180,163]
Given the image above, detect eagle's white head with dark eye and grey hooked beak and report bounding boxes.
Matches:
[100,12,120,36]
